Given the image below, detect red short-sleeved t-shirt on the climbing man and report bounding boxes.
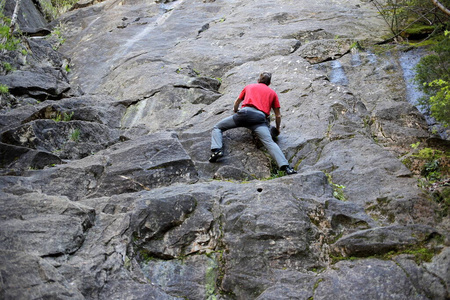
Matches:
[239,83,280,115]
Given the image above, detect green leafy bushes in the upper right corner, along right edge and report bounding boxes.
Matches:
[372,0,450,127]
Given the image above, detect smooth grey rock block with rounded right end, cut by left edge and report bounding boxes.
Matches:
[0,193,95,256]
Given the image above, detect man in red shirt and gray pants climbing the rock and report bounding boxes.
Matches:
[209,72,297,175]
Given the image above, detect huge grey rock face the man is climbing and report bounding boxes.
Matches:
[0,0,450,300]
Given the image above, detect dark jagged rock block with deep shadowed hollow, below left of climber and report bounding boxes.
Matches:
[130,192,218,259]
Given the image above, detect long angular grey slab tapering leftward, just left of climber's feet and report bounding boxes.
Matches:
[15,132,198,200]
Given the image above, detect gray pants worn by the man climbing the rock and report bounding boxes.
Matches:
[211,107,289,167]
